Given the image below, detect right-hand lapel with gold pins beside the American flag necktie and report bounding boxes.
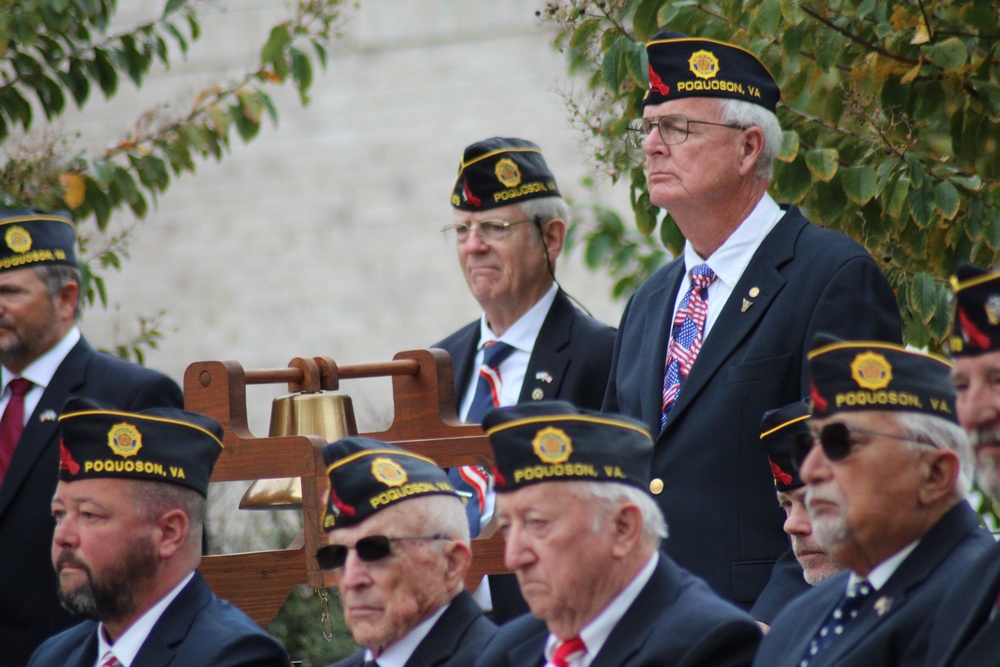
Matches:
[661,215,807,430]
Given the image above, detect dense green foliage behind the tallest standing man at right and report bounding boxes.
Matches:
[539,0,1000,349]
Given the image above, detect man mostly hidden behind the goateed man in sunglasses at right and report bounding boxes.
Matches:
[750,401,841,624]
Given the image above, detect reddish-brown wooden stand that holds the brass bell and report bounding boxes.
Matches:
[184,350,509,627]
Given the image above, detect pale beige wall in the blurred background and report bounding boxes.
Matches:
[65,0,627,434]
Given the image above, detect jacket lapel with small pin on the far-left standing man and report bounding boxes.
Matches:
[0,338,93,514]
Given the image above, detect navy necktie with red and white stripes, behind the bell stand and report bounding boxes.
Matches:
[448,340,514,537]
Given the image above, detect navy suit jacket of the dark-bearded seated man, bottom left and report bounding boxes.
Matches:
[28,573,290,667]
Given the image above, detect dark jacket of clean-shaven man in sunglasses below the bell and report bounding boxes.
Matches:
[330,591,497,667]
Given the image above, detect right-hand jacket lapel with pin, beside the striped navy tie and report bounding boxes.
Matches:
[518,290,576,403]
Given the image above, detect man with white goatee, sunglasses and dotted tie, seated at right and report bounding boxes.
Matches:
[754,336,994,667]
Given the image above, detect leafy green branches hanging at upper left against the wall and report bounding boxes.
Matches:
[0,0,343,359]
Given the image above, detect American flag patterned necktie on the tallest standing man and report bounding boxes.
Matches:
[660,264,715,429]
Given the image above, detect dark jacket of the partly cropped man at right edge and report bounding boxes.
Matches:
[912,545,1000,667]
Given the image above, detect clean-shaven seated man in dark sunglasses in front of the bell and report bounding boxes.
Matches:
[316,437,496,667]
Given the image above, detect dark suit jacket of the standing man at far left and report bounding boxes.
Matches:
[0,338,184,667]
